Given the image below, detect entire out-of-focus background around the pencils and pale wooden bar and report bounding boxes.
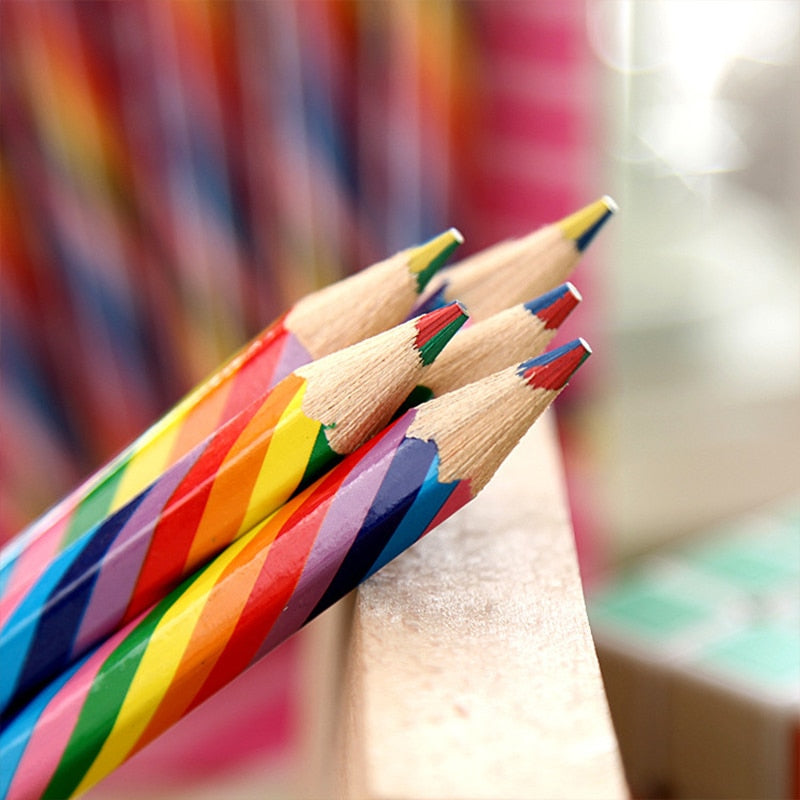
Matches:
[0,0,800,798]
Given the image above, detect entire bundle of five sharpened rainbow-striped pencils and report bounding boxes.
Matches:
[0,198,614,798]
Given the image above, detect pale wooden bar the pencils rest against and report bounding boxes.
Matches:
[337,412,628,800]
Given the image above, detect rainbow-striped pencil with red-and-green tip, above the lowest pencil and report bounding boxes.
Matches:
[0,303,466,711]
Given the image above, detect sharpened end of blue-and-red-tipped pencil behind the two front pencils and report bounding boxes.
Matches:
[402,282,581,410]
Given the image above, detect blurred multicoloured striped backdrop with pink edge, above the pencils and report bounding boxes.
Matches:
[0,1,596,538]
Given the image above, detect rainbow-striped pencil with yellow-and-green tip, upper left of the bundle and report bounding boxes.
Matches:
[0,228,463,623]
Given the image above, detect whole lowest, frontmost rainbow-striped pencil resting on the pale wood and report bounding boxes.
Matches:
[0,340,589,800]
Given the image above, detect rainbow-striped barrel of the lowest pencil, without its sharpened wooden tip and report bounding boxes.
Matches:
[0,412,471,800]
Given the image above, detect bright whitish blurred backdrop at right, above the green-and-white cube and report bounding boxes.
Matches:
[587,0,800,558]
